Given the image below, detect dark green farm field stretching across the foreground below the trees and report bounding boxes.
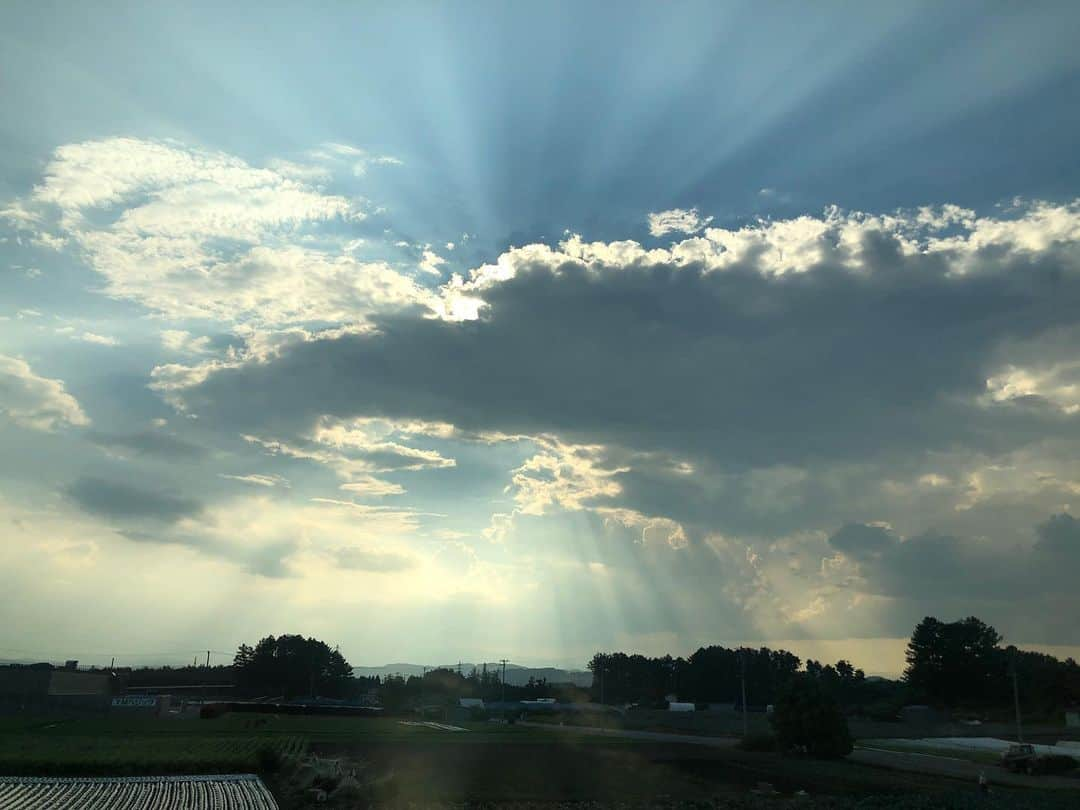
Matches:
[0,714,1075,810]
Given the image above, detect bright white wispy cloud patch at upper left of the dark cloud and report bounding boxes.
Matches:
[12,138,430,327]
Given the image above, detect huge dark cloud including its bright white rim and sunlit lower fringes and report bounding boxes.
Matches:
[135,195,1080,637]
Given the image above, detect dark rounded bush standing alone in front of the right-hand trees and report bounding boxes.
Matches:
[770,673,854,759]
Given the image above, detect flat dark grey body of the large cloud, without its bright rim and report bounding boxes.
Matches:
[186,234,1080,470]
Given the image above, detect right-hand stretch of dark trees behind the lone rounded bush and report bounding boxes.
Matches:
[589,617,1080,719]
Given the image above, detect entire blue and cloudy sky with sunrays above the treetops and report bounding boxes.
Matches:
[0,2,1080,674]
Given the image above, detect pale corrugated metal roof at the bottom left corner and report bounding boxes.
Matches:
[0,773,278,810]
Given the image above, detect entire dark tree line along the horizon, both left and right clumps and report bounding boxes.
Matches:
[131,617,1080,719]
